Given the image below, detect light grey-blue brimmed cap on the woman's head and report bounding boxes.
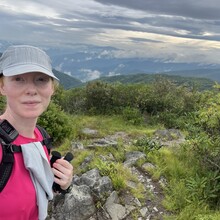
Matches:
[0,45,59,80]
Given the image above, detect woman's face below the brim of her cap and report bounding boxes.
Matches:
[0,72,54,119]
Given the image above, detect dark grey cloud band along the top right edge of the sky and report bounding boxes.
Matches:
[95,0,220,20]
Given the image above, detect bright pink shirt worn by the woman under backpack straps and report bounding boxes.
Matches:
[0,128,49,220]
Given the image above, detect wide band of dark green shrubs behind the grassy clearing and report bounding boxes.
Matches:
[54,76,200,131]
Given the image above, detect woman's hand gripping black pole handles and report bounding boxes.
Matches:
[52,159,73,190]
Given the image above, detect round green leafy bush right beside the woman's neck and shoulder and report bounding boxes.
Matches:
[38,102,72,146]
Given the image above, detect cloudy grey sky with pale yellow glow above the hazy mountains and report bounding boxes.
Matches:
[0,0,220,66]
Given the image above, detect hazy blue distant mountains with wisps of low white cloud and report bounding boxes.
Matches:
[0,41,220,84]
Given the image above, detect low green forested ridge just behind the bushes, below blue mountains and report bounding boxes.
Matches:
[90,73,214,90]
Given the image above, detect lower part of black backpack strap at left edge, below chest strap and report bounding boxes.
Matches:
[0,144,14,192]
